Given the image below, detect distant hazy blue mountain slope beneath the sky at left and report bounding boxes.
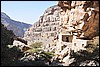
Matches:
[1,12,31,37]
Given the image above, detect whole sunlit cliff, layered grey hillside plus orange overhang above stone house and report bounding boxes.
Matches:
[24,1,99,44]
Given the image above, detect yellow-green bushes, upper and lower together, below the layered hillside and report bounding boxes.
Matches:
[25,42,54,61]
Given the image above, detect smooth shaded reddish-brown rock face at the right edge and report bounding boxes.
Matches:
[82,10,99,39]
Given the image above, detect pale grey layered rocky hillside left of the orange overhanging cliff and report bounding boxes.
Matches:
[24,5,61,44]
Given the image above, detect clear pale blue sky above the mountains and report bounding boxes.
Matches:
[1,1,58,24]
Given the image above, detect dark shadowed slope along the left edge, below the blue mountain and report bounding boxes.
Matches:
[1,24,22,66]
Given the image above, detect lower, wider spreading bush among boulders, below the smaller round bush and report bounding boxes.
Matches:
[25,48,54,61]
